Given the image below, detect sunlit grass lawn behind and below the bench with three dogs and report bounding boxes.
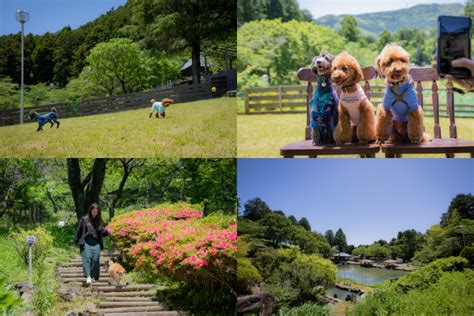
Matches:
[237,114,474,158]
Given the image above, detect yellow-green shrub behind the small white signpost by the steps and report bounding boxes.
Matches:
[10,227,53,264]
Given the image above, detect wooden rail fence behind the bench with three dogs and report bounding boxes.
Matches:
[245,85,474,118]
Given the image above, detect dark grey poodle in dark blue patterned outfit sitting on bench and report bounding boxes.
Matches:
[309,52,339,146]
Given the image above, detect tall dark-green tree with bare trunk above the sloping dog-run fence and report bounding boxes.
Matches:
[135,0,237,83]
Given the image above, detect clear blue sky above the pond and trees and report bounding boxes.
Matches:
[238,159,474,245]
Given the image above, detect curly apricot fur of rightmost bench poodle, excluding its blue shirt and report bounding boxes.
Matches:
[376,43,431,143]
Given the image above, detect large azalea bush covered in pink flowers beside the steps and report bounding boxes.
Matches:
[107,204,237,282]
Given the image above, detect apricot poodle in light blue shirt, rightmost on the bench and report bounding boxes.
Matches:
[376,43,431,144]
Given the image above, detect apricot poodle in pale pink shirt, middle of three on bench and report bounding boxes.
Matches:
[331,52,375,144]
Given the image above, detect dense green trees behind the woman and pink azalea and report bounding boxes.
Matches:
[0,158,237,226]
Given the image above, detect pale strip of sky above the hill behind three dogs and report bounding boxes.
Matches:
[298,0,466,18]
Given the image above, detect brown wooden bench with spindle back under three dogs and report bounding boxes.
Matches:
[280,66,474,158]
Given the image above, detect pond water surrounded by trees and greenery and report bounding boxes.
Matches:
[337,264,407,284]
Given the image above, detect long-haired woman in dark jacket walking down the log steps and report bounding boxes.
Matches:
[74,203,110,284]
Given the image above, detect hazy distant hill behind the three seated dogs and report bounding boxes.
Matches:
[315,3,464,34]
